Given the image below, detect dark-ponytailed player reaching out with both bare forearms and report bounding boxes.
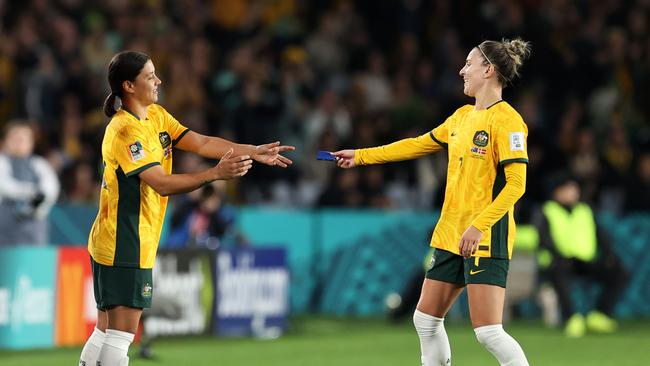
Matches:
[79,51,294,366]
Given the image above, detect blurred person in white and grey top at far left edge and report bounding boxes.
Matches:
[0,120,59,246]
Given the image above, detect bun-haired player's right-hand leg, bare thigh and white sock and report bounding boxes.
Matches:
[467,284,528,366]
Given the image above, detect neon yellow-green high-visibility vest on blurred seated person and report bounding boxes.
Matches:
[542,201,598,262]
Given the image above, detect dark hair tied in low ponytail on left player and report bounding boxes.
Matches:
[104,51,151,117]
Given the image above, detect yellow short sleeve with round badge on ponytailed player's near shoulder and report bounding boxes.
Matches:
[113,126,160,177]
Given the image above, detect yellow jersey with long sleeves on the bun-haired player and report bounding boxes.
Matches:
[355,101,528,258]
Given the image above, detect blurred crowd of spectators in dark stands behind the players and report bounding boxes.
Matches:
[0,0,650,219]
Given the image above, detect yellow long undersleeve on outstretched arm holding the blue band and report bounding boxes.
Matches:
[354,133,443,165]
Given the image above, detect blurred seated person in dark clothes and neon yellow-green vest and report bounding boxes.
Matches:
[535,172,628,337]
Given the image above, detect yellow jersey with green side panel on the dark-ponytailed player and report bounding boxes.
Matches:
[88,104,189,268]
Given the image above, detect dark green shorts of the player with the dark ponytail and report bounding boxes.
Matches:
[90,257,153,310]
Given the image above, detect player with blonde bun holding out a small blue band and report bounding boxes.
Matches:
[334,39,530,366]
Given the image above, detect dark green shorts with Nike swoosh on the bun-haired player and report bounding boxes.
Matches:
[425,249,510,288]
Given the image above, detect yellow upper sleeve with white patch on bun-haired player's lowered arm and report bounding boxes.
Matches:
[494,118,528,165]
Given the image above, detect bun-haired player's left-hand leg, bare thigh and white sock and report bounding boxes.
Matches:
[413,279,463,366]
